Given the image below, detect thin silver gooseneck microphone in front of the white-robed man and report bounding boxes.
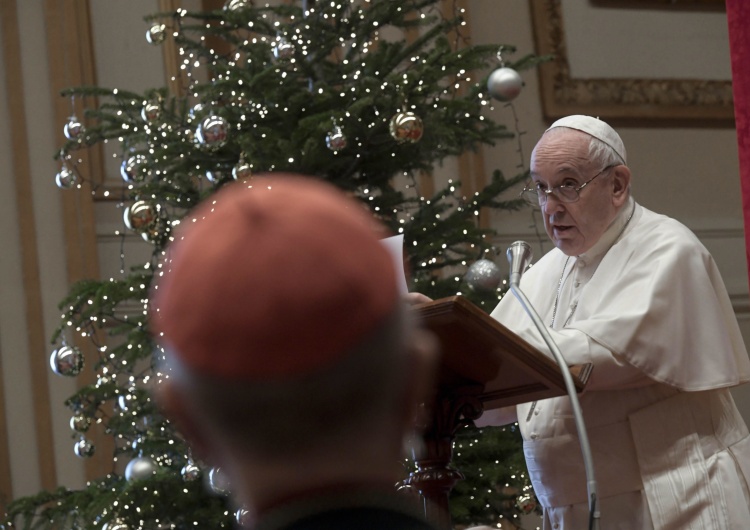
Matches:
[507,241,600,530]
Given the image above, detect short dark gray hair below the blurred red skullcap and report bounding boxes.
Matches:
[162,303,413,458]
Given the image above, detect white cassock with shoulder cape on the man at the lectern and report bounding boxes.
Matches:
[492,199,750,530]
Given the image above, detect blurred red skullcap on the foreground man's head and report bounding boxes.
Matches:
[151,174,400,379]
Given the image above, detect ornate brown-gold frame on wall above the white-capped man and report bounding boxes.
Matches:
[529,0,734,127]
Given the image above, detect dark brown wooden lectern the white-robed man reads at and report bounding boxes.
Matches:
[402,296,591,530]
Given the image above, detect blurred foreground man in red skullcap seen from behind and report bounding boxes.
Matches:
[152,175,435,530]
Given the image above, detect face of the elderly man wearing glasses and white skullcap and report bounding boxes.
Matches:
[531,129,624,256]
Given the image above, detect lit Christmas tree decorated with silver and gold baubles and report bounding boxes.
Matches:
[4,0,539,530]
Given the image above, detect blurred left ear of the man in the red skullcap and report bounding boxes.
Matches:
[154,379,211,462]
